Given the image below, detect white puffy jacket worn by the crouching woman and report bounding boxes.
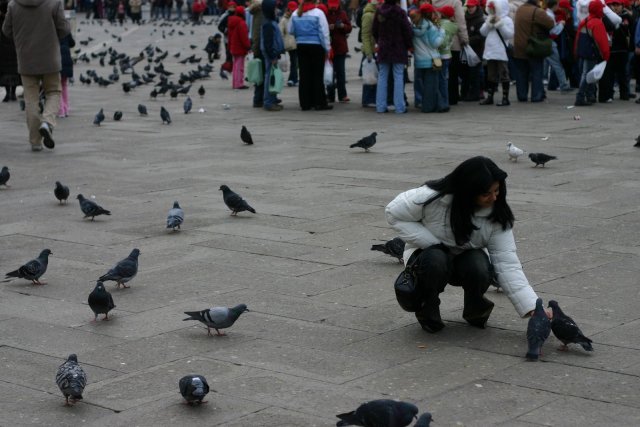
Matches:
[385,185,537,316]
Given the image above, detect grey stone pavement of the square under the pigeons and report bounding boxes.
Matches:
[0,14,640,427]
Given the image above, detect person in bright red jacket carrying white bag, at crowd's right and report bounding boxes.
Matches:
[574,0,609,107]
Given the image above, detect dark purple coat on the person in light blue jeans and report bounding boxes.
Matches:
[372,3,413,64]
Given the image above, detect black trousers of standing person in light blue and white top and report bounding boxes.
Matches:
[297,44,328,110]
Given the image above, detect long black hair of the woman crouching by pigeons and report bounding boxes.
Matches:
[423,156,514,245]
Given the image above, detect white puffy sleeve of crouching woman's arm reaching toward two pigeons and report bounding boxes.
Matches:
[487,228,538,317]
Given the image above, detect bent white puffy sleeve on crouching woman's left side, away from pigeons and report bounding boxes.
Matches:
[384,188,440,248]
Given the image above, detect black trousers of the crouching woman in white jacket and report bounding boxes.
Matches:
[409,245,494,320]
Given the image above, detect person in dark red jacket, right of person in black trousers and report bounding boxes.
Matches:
[327,0,352,103]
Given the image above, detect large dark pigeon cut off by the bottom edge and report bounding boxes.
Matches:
[336,399,418,427]
